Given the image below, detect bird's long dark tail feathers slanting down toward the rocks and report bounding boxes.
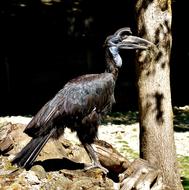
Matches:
[11,128,55,169]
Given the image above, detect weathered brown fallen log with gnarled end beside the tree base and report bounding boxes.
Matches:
[94,140,163,190]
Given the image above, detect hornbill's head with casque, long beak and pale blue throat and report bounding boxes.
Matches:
[104,27,154,67]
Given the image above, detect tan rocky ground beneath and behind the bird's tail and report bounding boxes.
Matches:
[0,122,113,190]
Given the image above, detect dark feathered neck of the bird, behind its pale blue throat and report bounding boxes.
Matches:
[105,51,119,80]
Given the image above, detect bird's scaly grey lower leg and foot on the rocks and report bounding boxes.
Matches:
[83,144,108,174]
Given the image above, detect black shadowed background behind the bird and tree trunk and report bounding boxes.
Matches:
[0,0,189,116]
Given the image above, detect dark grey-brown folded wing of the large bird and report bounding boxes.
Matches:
[24,73,114,136]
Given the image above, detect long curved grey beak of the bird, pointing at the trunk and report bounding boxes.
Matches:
[117,35,155,49]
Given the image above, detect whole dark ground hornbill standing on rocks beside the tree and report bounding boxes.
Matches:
[12,28,152,173]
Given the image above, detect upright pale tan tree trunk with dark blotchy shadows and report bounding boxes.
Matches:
[136,0,183,190]
